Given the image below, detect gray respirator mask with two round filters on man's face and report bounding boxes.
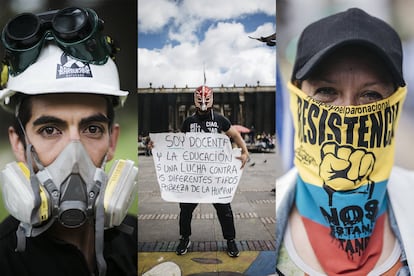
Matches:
[1,141,138,274]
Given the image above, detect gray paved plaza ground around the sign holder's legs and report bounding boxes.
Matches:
[138,153,281,275]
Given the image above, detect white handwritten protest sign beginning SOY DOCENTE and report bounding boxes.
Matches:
[150,132,242,203]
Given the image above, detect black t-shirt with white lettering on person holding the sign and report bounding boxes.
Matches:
[181,111,231,133]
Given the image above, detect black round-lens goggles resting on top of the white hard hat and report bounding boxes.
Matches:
[1,7,115,76]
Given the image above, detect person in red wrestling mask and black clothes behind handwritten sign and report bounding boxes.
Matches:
[175,85,249,257]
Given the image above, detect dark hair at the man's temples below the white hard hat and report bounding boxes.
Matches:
[12,93,115,147]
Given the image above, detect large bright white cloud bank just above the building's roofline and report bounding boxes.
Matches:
[138,23,276,87]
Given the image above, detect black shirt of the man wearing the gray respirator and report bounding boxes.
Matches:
[0,215,138,276]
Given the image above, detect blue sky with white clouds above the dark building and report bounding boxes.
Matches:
[138,0,276,87]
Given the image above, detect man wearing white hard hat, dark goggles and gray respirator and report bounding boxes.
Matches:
[0,7,137,276]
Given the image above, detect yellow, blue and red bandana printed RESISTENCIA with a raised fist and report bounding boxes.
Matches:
[288,83,407,275]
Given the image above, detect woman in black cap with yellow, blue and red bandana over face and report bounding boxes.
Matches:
[276,8,414,275]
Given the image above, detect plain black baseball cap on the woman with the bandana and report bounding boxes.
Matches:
[291,8,405,86]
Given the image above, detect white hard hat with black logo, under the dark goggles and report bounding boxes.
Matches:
[0,43,128,111]
